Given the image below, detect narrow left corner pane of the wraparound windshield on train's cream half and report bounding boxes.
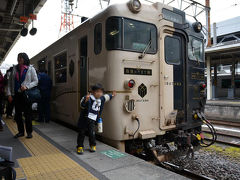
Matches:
[106,17,122,50]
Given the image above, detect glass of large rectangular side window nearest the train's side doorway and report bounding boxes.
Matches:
[54,52,67,83]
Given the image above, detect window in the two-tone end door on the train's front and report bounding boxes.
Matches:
[164,36,181,65]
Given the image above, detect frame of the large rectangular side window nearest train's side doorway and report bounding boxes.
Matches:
[53,50,68,85]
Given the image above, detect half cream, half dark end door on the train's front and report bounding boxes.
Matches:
[160,28,186,130]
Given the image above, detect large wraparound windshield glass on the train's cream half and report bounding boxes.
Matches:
[106,17,157,54]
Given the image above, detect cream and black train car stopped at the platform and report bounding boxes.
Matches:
[31,0,208,157]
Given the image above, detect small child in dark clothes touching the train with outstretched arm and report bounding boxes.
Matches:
[77,84,116,154]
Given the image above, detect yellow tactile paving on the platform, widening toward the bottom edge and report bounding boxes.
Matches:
[6,120,97,180]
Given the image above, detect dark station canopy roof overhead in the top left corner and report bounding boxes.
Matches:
[0,0,46,62]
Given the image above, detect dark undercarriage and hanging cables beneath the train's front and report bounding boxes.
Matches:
[125,115,217,162]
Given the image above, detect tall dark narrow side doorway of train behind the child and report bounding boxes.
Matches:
[78,36,88,110]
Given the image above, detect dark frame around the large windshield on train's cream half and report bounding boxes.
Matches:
[105,16,158,55]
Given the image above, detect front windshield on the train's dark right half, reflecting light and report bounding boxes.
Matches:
[188,38,204,62]
